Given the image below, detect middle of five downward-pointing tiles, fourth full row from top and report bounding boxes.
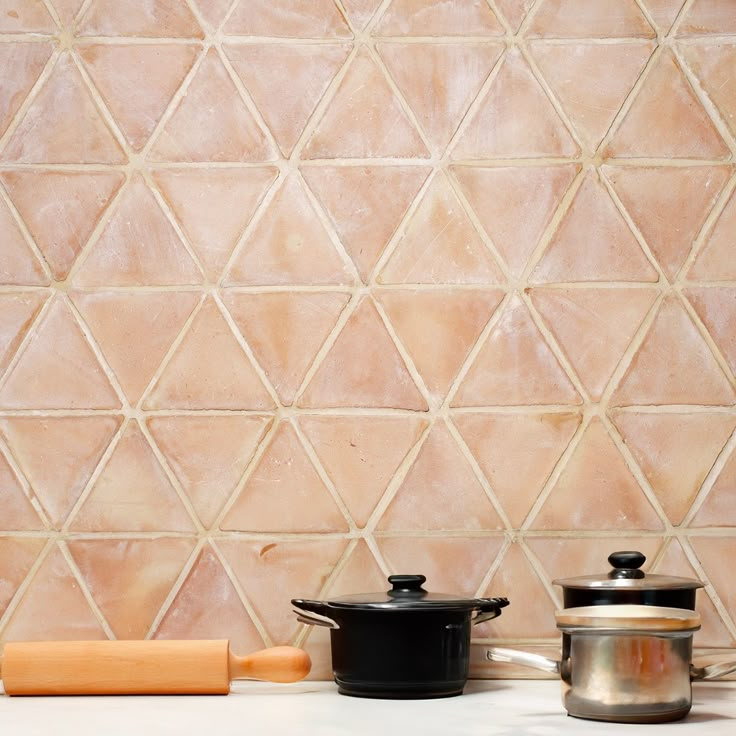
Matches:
[299,415,427,527]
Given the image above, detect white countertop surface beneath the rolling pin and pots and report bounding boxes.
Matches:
[0,680,736,736]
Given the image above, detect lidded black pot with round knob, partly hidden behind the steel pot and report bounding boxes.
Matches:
[552,552,703,611]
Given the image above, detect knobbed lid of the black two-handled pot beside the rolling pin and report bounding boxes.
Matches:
[325,575,508,611]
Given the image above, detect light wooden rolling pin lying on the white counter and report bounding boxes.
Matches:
[0,639,312,695]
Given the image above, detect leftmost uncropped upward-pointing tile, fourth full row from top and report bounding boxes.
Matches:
[72,420,194,532]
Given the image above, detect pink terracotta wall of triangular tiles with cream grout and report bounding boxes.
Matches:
[0,0,736,677]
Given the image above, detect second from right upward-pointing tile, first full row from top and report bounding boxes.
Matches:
[452,49,580,159]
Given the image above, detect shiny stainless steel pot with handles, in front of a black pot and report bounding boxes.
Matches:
[486,605,736,723]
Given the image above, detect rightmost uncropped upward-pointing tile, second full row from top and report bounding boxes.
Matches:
[532,172,658,283]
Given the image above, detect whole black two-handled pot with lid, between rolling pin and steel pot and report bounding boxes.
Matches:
[291,575,508,698]
